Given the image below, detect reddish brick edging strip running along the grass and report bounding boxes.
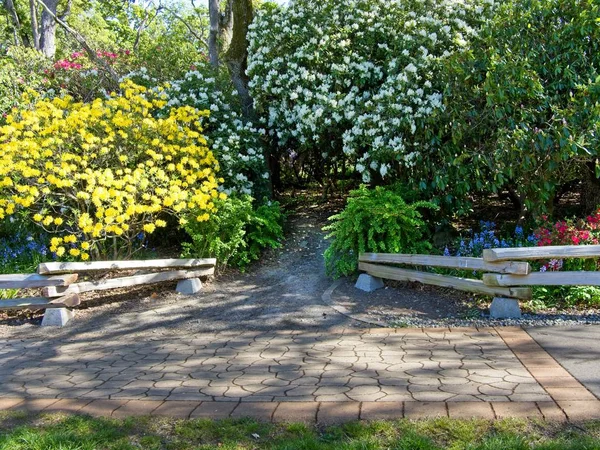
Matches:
[0,398,600,424]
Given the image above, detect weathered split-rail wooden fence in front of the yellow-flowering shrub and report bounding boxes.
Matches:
[0,258,217,309]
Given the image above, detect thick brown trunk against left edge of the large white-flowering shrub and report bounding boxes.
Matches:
[225,0,254,118]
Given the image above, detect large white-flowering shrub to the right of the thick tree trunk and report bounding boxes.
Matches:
[248,0,493,182]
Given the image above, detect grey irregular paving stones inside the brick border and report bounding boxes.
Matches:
[0,330,551,402]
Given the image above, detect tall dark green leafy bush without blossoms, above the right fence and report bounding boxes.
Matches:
[440,0,600,215]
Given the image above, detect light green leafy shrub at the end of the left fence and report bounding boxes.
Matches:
[182,195,284,269]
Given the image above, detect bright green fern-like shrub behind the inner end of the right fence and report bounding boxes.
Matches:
[324,185,437,278]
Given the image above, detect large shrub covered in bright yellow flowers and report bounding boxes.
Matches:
[0,81,224,261]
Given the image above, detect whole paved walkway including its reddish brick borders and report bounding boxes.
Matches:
[0,328,600,420]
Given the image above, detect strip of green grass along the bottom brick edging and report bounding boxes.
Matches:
[0,413,600,450]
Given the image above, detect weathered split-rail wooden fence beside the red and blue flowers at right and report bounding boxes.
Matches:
[359,245,600,300]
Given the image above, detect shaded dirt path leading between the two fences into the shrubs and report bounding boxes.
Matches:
[0,202,363,338]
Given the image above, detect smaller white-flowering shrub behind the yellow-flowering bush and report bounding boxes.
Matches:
[165,65,269,198]
